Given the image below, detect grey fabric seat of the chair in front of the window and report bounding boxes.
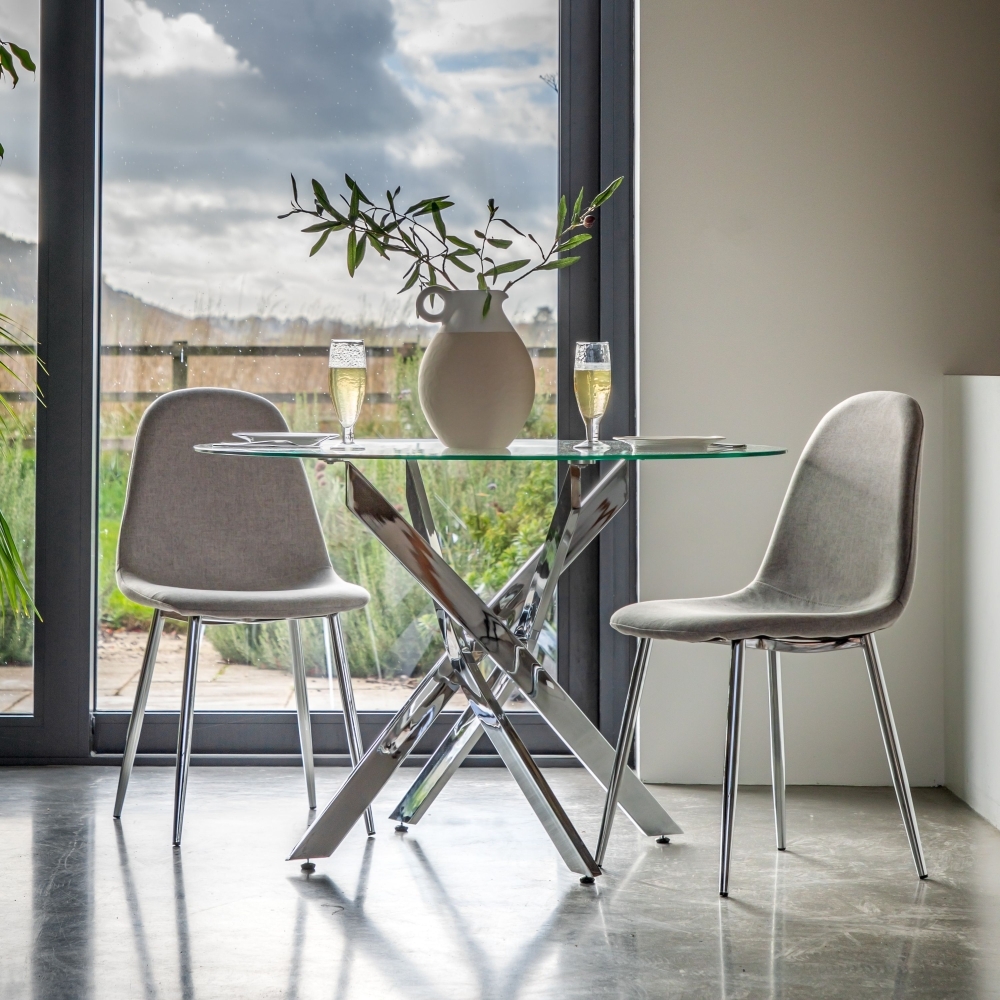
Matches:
[118,569,370,621]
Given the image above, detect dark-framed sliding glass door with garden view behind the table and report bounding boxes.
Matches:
[0,0,634,760]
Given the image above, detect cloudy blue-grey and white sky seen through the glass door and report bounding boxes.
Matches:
[0,0,557,319]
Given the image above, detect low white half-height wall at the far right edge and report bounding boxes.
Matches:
[945,375,1000,826]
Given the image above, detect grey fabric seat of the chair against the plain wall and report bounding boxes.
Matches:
[611,581,902,642]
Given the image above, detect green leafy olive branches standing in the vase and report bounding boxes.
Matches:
[278,174,623,316]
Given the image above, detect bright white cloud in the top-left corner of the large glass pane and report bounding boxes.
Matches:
[104,0,257,79]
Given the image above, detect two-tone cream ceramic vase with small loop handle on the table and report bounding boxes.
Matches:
[417,287,535,451]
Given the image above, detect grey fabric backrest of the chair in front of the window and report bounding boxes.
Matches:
[118,389,330,590]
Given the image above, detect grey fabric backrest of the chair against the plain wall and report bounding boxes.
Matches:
[756,392,924,613]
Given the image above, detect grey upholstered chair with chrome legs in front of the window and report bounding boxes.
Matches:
[114,389,374,844]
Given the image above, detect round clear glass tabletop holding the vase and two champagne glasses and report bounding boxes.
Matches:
[195,434,785,462]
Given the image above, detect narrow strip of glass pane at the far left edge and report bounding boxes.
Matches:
[0,0,39,715]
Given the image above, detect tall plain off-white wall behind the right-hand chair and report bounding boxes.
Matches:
[640,0,1000,785]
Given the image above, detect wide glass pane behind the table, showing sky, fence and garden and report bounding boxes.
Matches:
[97,0,558,709]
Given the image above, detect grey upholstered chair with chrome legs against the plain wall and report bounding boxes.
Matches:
[596,392,927,896]
